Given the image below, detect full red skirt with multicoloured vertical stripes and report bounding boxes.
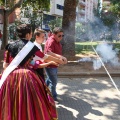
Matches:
[0,67,58,120]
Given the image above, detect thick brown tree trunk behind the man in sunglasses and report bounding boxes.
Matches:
[62,0,77,58]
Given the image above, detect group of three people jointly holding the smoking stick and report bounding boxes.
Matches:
[0,24,67,120]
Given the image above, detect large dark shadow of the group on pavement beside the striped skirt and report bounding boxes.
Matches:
[57,94,103,120]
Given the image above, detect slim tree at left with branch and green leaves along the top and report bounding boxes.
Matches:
[0,0,50,49]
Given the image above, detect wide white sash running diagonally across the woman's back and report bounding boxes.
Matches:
[0,41,34,88]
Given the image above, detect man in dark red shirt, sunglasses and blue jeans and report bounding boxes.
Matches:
[44,27,67,101]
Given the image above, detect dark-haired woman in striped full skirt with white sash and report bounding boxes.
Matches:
[0,24,63,120]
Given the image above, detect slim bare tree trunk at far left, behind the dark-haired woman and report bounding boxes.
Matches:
[1,11,8,50]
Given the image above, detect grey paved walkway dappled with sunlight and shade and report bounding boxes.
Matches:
[56,77,120,120]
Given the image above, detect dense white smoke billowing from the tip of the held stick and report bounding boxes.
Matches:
[78,42,120,70]
